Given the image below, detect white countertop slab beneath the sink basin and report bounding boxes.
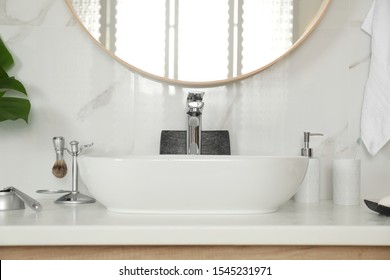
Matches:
[0,198,390,246]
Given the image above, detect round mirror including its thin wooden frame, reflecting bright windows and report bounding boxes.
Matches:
[66,0,330,87]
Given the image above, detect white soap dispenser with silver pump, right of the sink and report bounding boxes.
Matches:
[294,132,323,203]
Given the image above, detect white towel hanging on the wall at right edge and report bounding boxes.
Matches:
[361,0,390,155]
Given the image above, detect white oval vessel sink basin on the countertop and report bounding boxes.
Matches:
[79,155,308,214]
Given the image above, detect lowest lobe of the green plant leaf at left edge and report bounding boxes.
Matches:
[0,97,31,123]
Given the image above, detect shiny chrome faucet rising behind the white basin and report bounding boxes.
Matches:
[187,91,204,155]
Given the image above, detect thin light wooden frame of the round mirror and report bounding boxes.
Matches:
[65,0,331,88]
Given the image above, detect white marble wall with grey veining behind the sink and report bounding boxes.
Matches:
[0,0,390,199]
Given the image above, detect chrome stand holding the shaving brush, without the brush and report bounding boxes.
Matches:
[55,141,96,204]
